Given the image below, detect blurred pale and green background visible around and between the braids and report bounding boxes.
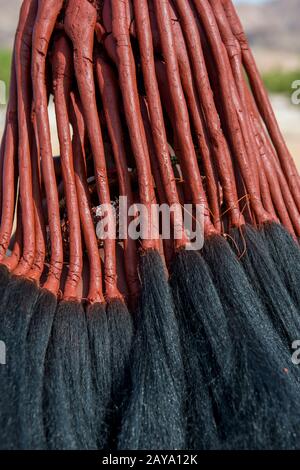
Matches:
[0,0,300,170]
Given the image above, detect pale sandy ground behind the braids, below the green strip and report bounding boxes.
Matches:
[0,95,300,171]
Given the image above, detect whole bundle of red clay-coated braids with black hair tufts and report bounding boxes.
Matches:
[0,0,300,450]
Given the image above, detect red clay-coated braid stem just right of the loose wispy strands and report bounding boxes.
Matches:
[194,0,271,224]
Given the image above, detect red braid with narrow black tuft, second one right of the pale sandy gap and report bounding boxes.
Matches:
[70,93,112,449]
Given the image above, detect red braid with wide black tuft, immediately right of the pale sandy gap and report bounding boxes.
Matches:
[42,36,96,449]
